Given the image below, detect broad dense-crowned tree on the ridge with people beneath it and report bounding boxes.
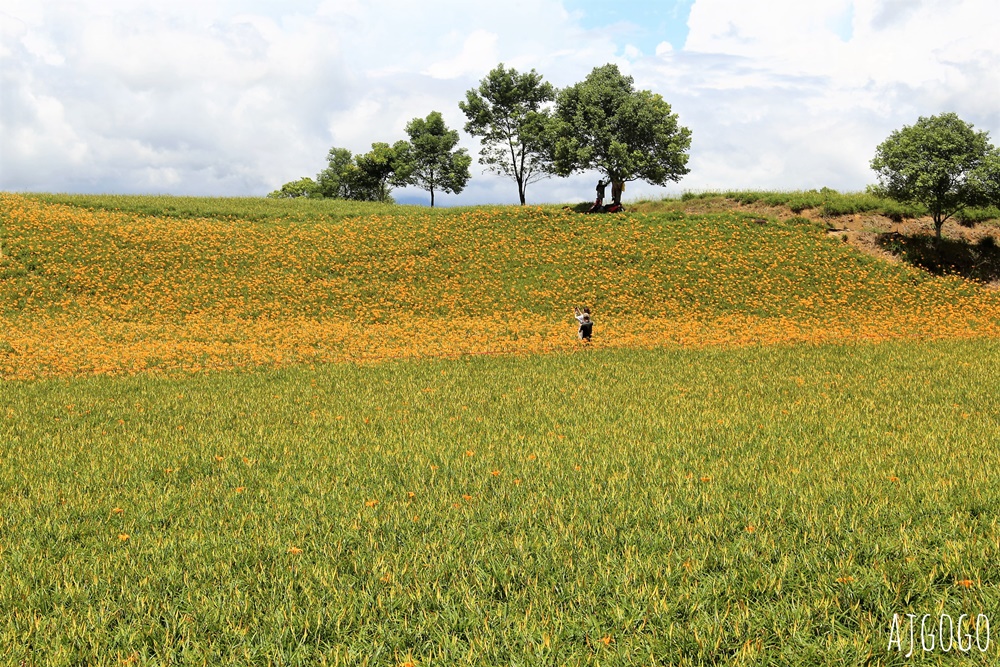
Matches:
[552,64,691,203]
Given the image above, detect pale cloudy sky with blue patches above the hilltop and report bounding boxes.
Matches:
[0,0,1000,205]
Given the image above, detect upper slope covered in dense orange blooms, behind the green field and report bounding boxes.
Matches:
[0,194,1000,378]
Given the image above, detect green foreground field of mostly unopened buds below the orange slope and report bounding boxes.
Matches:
[0,340,1000,667]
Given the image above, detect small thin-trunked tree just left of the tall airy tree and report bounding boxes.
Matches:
[399,111,472,206]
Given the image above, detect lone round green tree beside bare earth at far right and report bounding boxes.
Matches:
[871,113,1000,240]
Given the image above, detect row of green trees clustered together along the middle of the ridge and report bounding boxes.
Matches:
[268,63,691,206]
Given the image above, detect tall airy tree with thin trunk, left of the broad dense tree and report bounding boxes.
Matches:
[458,63,555,205]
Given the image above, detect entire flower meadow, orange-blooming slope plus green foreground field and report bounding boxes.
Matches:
[0,194,1000,667]
